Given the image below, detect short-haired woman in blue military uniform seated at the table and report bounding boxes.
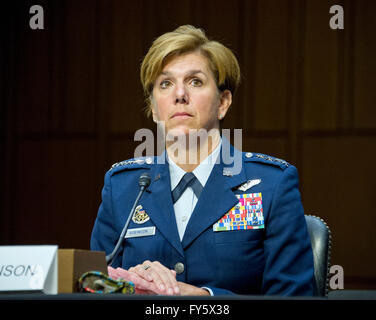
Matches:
[91,26,314,296]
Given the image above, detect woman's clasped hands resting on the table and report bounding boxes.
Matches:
[108,260,209,295]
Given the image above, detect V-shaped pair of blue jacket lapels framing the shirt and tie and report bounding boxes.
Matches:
[142,137,251,252]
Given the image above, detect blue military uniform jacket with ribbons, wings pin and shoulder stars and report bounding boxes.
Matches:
[91,144,314,296]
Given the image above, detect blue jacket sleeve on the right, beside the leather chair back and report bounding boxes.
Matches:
[262,166,314,296]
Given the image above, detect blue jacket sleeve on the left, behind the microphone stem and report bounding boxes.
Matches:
[90,171,121,266]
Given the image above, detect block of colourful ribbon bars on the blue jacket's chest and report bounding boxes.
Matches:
[213,192,264,231]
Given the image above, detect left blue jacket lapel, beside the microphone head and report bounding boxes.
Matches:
[143,154,184,256]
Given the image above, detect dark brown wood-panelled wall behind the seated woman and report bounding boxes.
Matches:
[0,0,376,289]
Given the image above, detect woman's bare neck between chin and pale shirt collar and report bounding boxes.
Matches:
[166,130,221,172]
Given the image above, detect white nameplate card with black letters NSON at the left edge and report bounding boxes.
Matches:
[0,246,58,294]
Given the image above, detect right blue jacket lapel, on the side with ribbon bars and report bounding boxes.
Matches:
[182,145,247,249]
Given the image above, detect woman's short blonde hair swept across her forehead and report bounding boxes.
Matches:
[140,25,240,116]
